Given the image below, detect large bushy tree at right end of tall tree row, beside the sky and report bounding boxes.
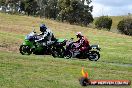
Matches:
[58,0,93,26]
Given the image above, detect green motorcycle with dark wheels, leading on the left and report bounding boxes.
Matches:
[19,30,65,57]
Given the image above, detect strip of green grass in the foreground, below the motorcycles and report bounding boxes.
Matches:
[0,52,132,88]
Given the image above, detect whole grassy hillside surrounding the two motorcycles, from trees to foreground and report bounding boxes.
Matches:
[0,13,132,88]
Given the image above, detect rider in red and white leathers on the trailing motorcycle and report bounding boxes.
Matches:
[75,32,90,52]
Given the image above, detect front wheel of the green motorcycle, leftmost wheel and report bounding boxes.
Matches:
[19,45,32,55]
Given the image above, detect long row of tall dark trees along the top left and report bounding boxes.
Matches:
[0,0,93,26]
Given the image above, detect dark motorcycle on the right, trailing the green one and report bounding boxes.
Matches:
[64,38,101,61]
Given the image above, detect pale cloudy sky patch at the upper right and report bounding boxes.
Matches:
[91,0,132,17]
